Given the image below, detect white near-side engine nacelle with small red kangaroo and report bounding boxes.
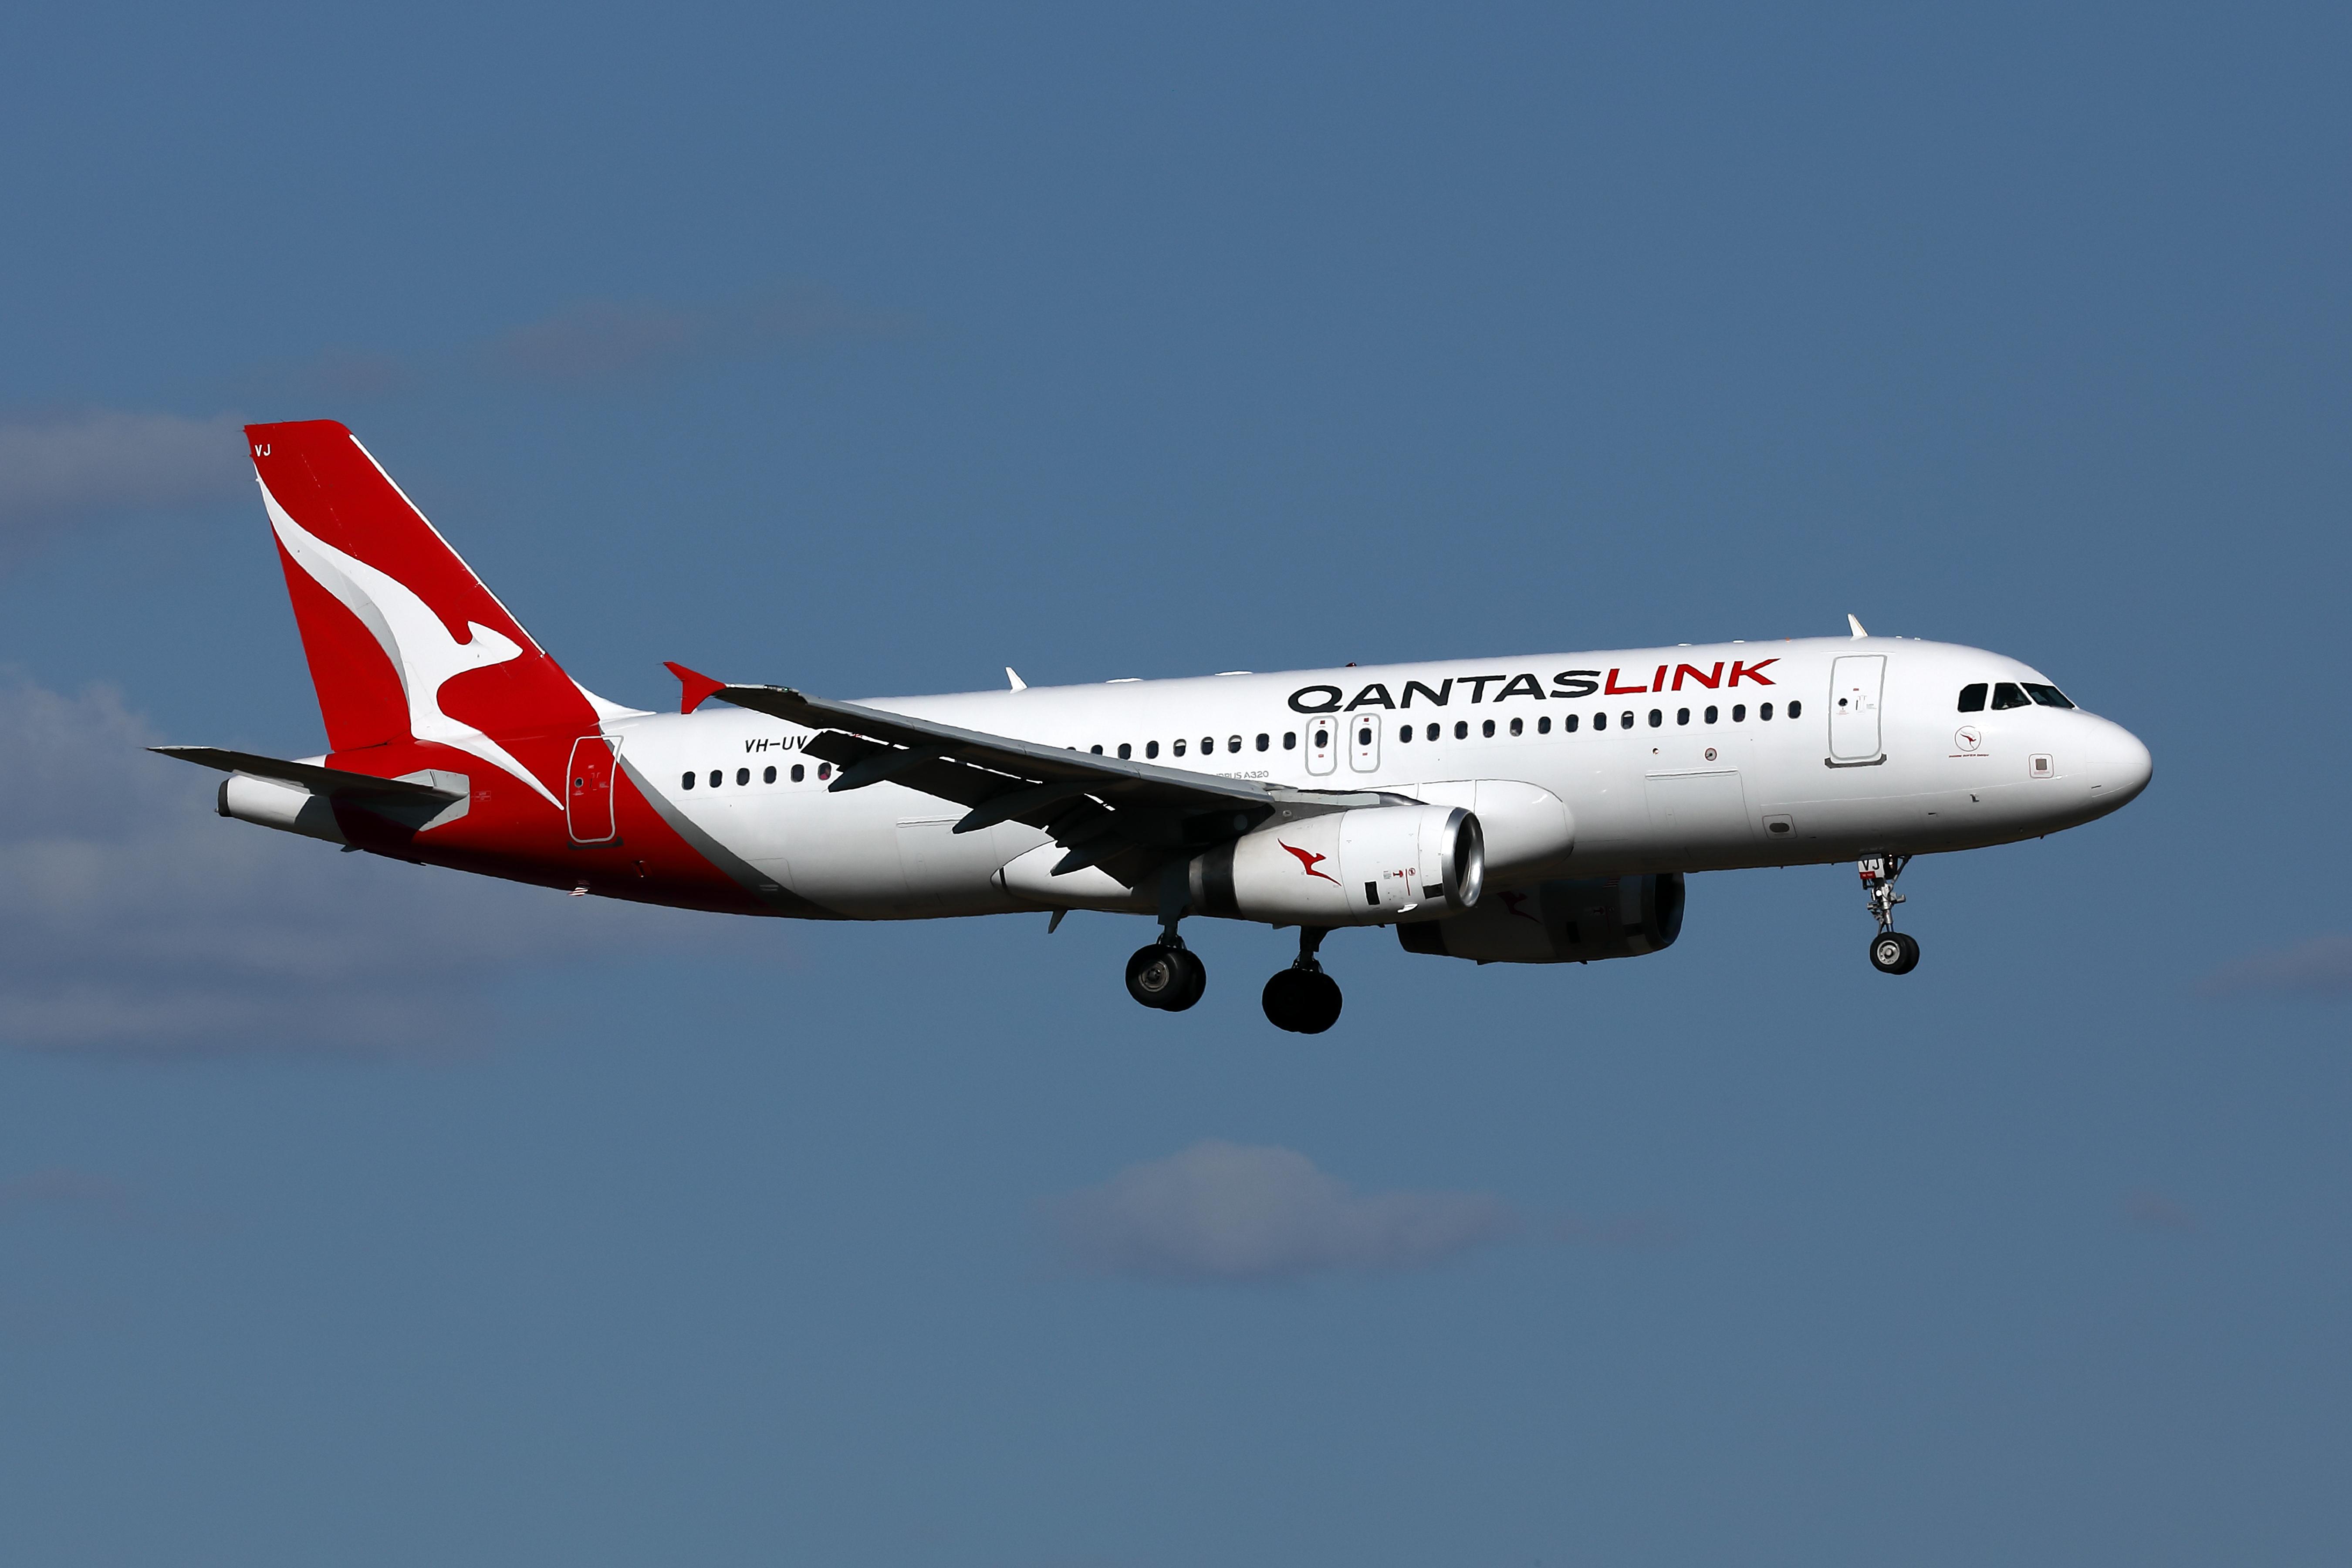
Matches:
[1193,806,1487,926]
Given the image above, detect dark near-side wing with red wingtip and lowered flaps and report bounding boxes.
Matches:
[672,665,1397,886]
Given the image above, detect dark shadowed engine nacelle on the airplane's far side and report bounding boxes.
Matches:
[1397,872,1682,964]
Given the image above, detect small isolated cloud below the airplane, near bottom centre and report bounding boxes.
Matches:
[1056,1138,1515,1281]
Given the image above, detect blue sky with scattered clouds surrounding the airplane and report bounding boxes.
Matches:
[0,7,2352,1568]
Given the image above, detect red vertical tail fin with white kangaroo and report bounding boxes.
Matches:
[245,419,598,801]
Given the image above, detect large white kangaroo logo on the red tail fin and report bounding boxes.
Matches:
[261,484,564,811]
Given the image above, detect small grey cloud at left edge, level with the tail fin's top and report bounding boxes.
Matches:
[0,412,249,543]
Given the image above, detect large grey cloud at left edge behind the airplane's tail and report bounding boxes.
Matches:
[0,679,710,1055]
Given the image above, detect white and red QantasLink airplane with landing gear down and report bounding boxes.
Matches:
[155,421,2152,1034]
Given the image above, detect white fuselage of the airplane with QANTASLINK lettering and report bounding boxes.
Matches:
[607,637,2150,919]
